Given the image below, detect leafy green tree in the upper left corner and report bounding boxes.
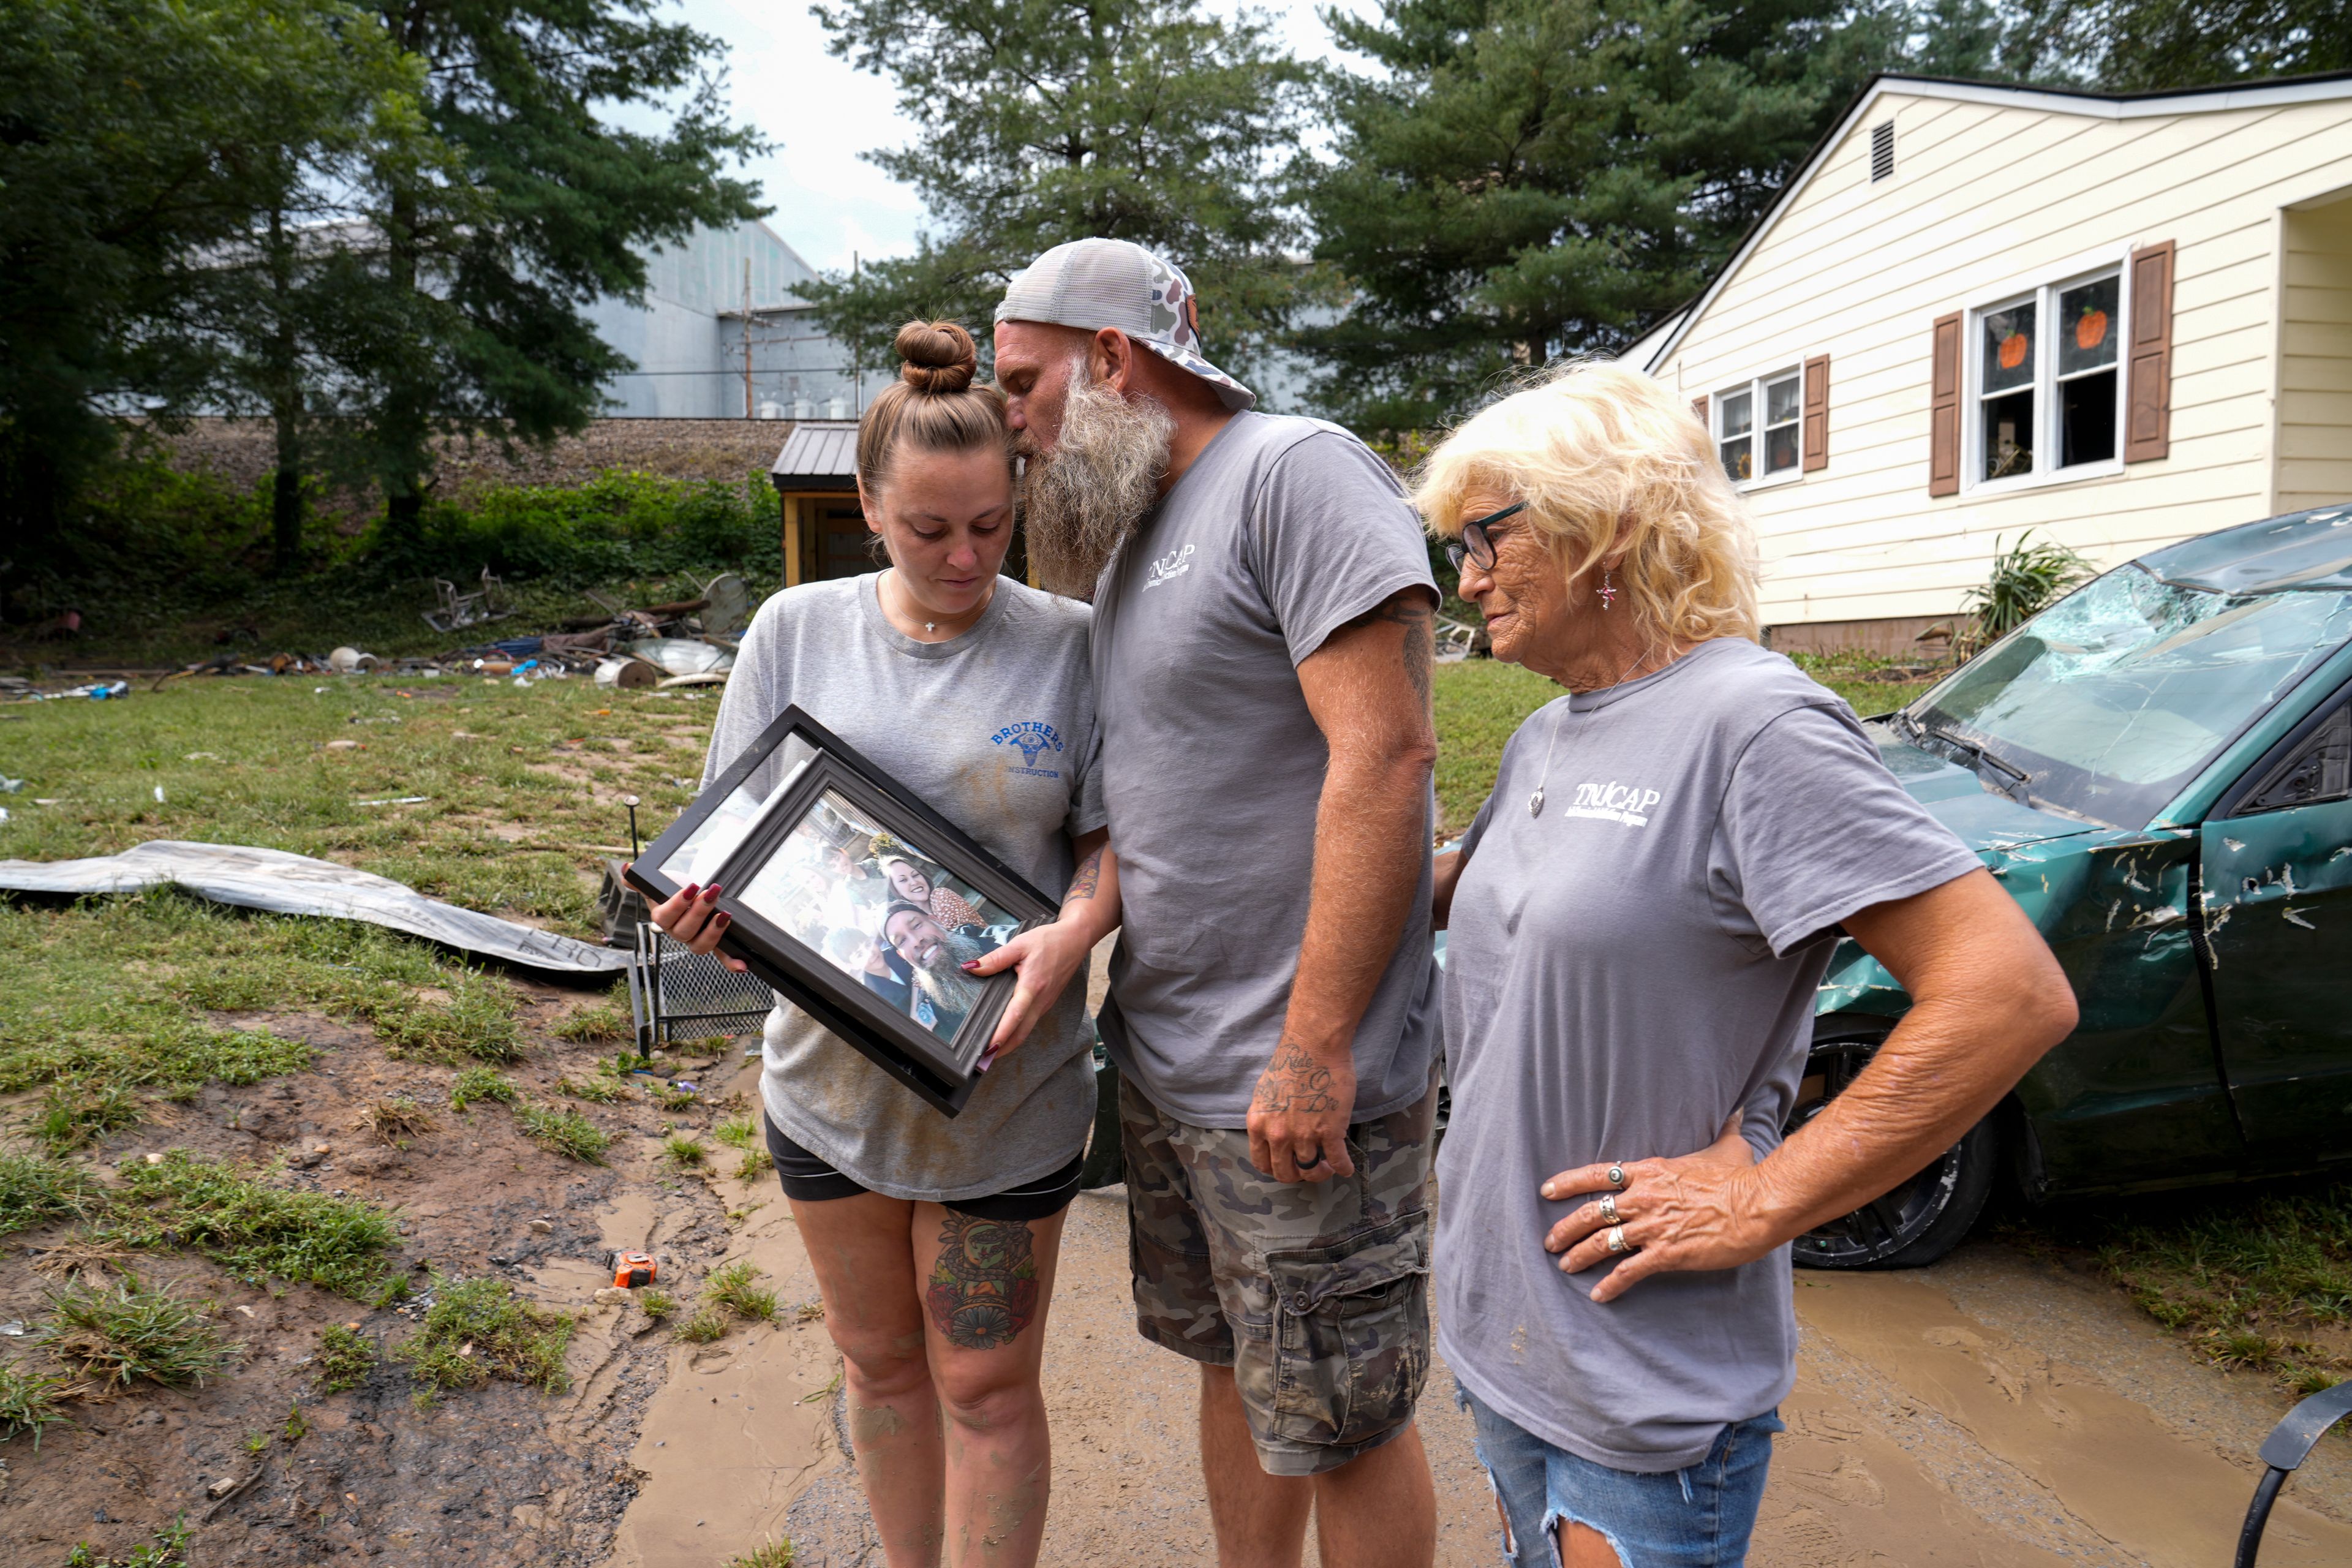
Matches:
[0,0,398,559]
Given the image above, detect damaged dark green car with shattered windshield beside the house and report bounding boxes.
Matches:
[1790,505,2352,1267]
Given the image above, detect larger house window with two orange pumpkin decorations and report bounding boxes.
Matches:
[1973,270,2124,484]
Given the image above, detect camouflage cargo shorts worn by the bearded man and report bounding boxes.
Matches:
[1120,1077,1437,1476]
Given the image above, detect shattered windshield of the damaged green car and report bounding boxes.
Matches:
[1905,567,2352,827]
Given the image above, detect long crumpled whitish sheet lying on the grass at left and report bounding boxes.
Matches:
[0,839,630,973]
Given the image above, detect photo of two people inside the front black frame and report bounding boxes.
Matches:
[734,790,1021,1041]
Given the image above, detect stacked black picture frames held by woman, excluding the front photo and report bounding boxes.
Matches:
[628,707,1058,1117]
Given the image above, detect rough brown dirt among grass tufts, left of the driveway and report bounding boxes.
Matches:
[0,982,757,1568]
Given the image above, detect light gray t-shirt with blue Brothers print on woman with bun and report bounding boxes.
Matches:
[703,573,1103,1201]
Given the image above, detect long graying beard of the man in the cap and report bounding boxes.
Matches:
[1021,360,1176,600]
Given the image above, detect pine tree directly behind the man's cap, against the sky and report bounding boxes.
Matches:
[802,0,1305,390]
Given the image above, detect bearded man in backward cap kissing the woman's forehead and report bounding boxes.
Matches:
[995,239,1437,1568]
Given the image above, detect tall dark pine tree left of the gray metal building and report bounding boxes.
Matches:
[341,0,762,555]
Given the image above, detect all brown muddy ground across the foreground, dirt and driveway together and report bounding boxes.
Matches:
[0,1030,2352,1568]
